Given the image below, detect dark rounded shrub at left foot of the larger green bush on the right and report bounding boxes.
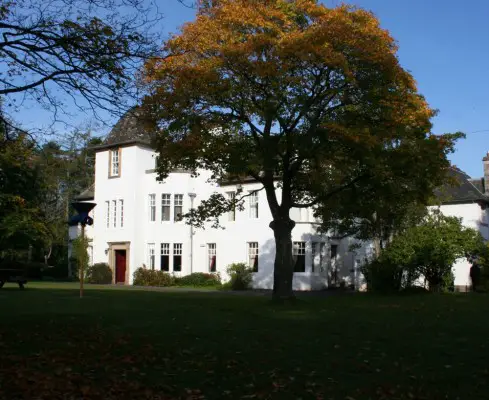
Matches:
[361,260,405,293]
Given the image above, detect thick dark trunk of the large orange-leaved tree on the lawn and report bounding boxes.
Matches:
[270,217,295,301]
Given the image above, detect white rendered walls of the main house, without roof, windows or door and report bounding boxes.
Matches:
[87,146,364,290]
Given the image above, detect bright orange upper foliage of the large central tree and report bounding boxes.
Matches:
[145,0,433,136]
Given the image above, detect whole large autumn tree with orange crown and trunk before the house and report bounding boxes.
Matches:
[145,0,460,298]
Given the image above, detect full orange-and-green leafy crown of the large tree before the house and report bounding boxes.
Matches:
[144,0,445,197]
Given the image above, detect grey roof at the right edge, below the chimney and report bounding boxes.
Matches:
[435,167,489,204]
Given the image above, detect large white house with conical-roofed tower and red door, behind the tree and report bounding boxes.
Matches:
[70,111,488,290]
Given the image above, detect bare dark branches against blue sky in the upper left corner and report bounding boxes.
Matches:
[0,0,161,127]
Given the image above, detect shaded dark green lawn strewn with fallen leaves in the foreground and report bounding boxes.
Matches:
[0,283,489,400]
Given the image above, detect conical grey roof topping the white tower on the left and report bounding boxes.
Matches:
[100,106,151,147]
